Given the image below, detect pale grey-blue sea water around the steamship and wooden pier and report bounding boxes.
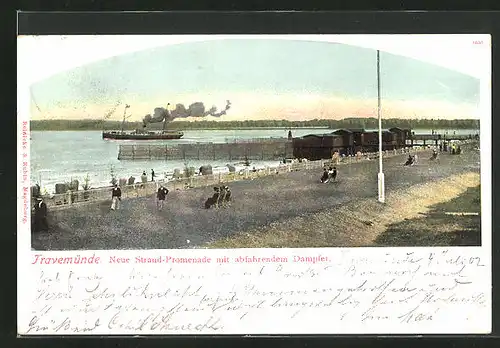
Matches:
[30,128,477,193]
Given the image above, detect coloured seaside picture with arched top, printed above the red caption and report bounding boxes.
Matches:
[26,35,481,250]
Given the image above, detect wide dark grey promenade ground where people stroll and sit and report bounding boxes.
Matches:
[33,150,479,250]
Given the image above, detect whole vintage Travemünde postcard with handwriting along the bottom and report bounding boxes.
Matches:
[18,35,491,335]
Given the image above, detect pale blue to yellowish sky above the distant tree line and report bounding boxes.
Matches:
[18,36,488,121]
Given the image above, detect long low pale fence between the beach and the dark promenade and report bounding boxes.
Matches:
[36,143,450,210]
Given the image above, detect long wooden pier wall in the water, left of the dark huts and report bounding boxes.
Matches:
[118,138,293,161]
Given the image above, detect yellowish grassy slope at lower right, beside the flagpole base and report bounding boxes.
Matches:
[208,172,481,248]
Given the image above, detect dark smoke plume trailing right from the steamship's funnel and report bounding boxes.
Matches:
[142,100,231,127]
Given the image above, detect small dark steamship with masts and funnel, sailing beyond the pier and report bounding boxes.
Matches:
[102,104,184,140]
